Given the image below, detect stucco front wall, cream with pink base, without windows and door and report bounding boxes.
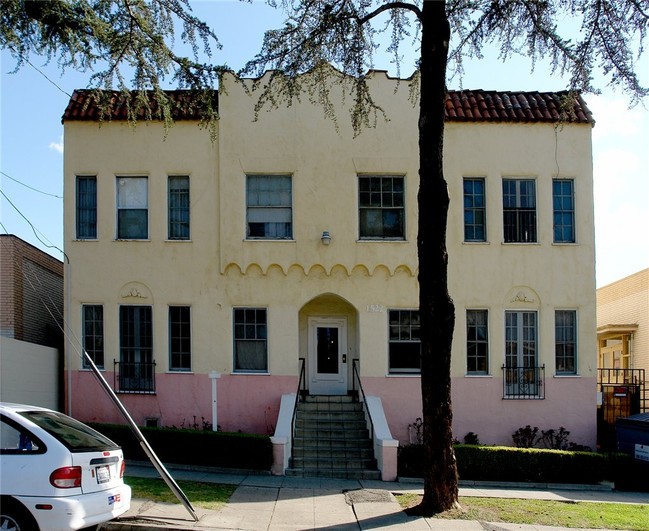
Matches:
[65,73,596,446]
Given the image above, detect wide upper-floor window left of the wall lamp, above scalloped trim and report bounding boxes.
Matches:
[246,175,293,240]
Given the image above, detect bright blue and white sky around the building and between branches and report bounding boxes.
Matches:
[0,0,649,287]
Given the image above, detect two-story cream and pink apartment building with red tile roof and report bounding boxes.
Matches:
[63,72,597,462]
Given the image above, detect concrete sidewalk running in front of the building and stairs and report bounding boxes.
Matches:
[100,464,649,531]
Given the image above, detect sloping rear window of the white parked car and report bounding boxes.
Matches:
[20,411,119,452]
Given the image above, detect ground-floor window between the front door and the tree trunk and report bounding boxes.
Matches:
[388,310,421,373]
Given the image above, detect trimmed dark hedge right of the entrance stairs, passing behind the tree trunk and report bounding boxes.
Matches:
[398,444,646,490]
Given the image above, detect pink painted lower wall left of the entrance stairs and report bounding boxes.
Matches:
[72,371,297,435]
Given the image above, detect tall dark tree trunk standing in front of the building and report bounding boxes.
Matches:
[417,1,458,514]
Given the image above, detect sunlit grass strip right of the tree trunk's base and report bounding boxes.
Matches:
[397,494,649,531]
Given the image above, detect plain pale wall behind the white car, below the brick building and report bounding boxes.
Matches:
[0,336,59,409]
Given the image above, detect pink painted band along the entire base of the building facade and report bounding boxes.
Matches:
[72,371,596,449]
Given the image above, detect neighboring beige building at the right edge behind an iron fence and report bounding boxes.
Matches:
[597,268,649,440]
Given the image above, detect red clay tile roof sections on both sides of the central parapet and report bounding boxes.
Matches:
[62,90,595,124]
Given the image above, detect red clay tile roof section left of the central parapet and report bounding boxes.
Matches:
[61,90,218,122]
